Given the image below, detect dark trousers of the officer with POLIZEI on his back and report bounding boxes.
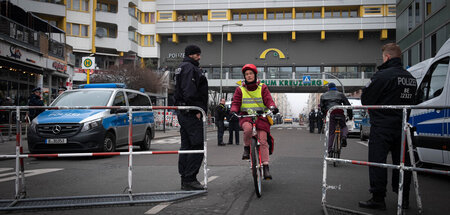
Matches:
[369,126,411,199]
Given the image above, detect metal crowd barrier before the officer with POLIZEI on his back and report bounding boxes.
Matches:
[322,105,450,215]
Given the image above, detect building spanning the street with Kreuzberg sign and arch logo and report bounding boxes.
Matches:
[156,0,396,92]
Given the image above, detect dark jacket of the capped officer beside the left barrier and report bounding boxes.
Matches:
[174,57,208,112]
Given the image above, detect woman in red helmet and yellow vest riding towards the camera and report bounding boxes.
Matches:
[231,64,278,179]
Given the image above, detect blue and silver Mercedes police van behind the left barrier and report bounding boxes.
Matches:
[27,83,155,153]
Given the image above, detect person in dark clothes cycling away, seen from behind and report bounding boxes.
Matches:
[320,82,353,153]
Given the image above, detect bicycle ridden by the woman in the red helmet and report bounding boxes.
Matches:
[235,110,272,198]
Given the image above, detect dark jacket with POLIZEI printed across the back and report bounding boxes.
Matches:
[361,58,417,129]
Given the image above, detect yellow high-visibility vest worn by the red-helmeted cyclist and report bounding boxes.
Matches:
[240,83,267,113]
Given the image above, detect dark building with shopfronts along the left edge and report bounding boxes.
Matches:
[0,1,74,105]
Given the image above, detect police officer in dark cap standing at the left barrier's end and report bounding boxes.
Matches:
[174,45,208,190]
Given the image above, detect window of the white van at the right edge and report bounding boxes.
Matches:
[417,57,449,103]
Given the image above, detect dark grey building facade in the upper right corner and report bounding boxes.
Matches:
[396,0,450,67]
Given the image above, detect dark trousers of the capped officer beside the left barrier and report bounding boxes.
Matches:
[178,113,204,182]
